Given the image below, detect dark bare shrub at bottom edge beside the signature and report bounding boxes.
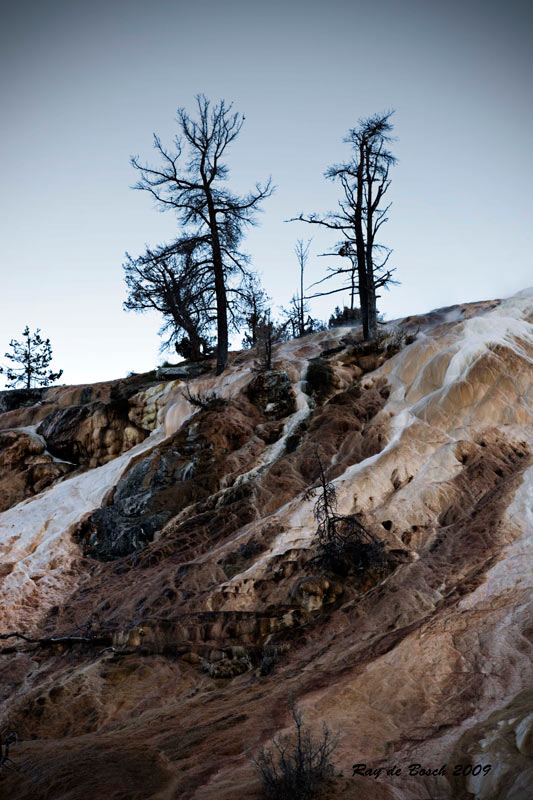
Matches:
[252,698,338,800]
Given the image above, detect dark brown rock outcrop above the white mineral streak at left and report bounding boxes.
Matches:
[0,374,167,511]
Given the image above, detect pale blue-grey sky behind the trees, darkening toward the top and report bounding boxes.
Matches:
[0,0,533,386]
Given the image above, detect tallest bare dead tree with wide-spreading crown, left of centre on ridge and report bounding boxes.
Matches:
[131,95,273,375]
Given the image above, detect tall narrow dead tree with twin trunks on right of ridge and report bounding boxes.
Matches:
[292,112,396,341]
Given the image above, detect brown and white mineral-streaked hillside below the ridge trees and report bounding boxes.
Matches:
[0,290,533,800]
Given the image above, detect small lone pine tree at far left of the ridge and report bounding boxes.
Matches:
[0,325,63,389]
